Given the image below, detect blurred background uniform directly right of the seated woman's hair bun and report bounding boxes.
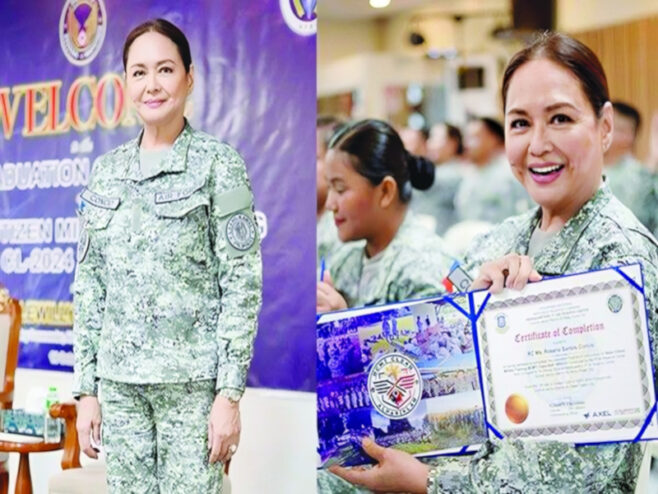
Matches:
[411,161,471,235]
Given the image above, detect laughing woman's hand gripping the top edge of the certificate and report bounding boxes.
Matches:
[470,254,541,294]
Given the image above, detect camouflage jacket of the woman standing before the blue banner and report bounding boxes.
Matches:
[73,124,262,399]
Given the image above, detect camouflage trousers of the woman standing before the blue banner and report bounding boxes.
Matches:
[101,380,223,494]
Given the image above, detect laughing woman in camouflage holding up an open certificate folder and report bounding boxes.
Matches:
[318,34,658,494]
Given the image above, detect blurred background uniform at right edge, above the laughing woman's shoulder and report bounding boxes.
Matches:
[603,154,658,230]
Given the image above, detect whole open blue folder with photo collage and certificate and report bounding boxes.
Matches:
[317,264,658,467]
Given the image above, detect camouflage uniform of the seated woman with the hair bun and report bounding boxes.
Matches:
[328,211,452,307]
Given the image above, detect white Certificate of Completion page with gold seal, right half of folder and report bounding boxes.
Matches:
[473,264,658,443]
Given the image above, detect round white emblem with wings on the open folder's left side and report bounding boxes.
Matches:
[368,353,423,419]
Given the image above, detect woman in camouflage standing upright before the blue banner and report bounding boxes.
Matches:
[73,19,261,494]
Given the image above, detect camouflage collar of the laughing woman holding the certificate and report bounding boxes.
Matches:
[511,182,612,275]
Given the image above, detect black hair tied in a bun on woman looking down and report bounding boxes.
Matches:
[329,120,434,203]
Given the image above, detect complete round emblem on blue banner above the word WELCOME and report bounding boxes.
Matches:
[59,0,107,66]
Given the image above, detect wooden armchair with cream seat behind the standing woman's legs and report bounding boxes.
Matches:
[48,402,231,494]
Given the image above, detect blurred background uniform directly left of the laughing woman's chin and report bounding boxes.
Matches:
[455,155,533,223]
